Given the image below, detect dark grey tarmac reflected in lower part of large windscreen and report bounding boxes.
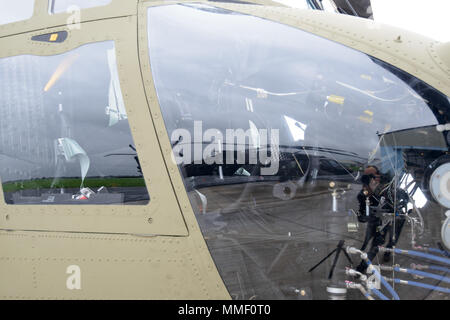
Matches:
[190,180,449,299]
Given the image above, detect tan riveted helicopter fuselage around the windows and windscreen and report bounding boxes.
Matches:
[0,0,450,299]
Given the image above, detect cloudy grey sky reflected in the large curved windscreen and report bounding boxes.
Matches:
[148,5,438,172]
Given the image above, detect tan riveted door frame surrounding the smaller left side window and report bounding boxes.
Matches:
[0,16,188,236]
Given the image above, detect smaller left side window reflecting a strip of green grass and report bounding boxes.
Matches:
[0,41,149,204]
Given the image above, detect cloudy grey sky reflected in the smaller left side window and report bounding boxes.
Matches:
[0,41,142,182]
